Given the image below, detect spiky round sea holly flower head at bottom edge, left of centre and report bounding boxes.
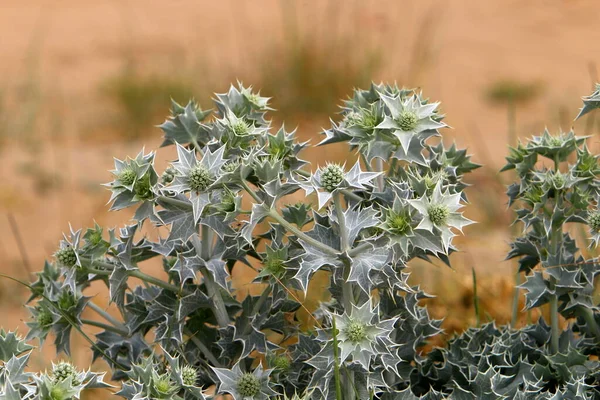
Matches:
[213,362,276,400]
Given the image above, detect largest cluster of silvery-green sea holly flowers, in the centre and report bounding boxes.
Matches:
[16,85,477,400]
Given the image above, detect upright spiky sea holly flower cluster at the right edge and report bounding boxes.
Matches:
[504,126,600,334]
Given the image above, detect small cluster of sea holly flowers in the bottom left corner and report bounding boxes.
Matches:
[0,330,110,400]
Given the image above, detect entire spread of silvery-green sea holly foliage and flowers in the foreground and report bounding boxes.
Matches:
[0,84,600,400]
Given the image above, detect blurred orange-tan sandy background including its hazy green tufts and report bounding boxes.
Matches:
[0,0,600,382]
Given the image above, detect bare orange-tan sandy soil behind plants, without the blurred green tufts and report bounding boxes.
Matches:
[0,0,600,374]
